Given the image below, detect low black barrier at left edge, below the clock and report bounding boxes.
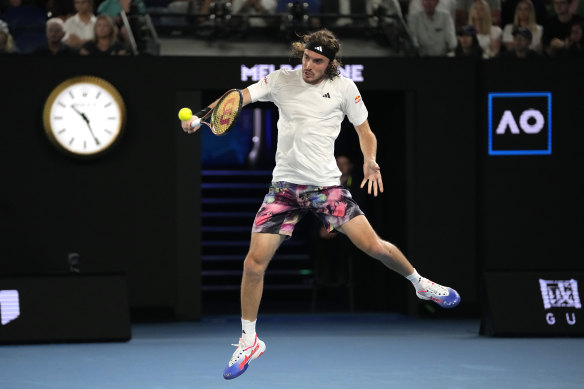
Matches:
[0,275,132,343]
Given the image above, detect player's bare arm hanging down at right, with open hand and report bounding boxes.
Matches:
[355,120,383,197]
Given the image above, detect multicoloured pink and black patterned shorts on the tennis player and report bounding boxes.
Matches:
[252,181,363,237]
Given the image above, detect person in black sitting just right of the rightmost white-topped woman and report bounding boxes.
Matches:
[542,0,582,57]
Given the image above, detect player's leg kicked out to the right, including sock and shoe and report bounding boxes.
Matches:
[336,215,460,308]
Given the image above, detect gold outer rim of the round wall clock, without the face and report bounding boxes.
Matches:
[43,75,126,158]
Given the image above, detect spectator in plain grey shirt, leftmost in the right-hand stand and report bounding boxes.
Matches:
[408,0,457,57]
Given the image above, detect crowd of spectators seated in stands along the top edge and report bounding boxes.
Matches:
[0,0,584,59]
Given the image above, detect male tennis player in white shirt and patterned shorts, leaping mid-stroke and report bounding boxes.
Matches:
[182,29,460,379]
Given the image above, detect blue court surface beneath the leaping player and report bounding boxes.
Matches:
[0,314,584,389]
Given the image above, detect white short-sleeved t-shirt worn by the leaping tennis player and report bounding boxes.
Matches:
[248,69,367,186]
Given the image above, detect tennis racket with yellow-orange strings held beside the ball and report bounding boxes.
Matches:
[184,89,243,135]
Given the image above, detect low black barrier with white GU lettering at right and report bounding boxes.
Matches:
[480,271,584,336]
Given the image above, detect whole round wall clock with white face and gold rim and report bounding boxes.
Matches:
[43,76,126,157]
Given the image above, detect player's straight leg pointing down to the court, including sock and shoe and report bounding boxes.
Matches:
[223,233,285,379]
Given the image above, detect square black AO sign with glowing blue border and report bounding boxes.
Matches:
[489,92,552,155]
